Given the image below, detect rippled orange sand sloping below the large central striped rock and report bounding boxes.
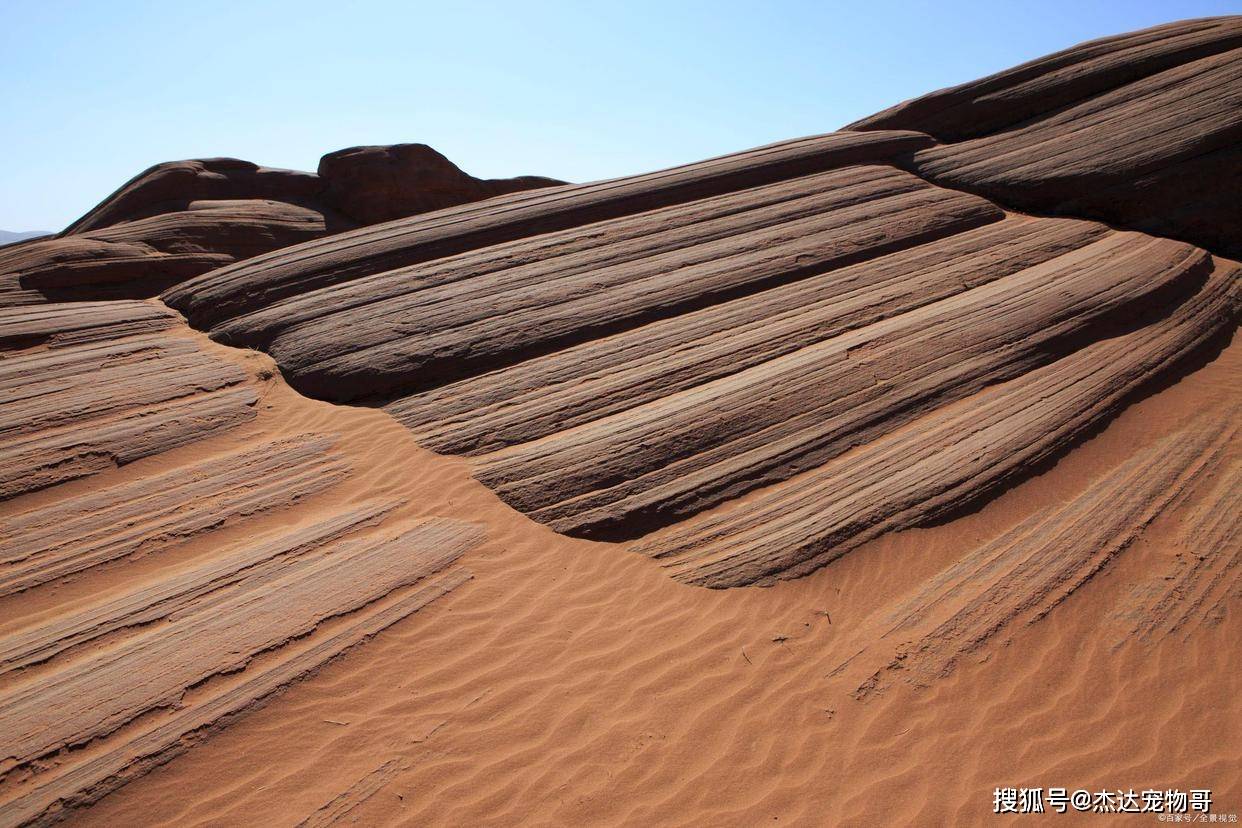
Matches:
[60,320,1242,826]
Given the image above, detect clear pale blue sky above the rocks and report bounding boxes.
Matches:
[0,0,1242,230]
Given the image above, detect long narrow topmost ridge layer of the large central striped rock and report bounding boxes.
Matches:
[164,133,932,332]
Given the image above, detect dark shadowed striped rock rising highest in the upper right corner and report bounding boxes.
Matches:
[847,16,1242,258]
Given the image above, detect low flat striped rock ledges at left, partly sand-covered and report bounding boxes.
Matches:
[0,296,481,826]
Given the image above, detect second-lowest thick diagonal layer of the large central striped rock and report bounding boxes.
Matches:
[478,237,1222,543]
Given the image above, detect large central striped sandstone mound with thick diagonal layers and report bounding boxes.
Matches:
[165,111,1240,587]
